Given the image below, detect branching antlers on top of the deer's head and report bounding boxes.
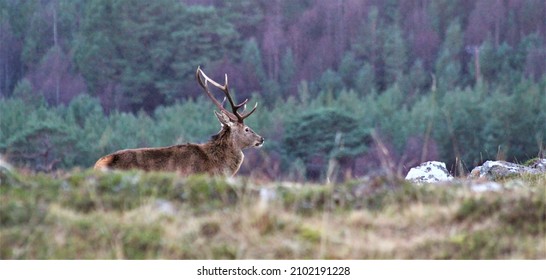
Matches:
[195,67,258,123]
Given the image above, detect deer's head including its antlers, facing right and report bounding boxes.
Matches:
[195,67,264,149]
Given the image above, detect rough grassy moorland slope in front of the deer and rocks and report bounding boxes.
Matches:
[0,167,546,259]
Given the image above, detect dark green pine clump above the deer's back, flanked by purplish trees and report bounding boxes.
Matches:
[75,0,238,109]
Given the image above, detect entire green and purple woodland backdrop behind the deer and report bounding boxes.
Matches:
[0,0,546,180]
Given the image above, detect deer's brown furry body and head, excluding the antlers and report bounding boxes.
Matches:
[95,114,263,176]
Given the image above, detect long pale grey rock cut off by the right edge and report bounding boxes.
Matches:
[469,159,546,180]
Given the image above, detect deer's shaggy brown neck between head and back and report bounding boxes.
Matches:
[205,130,244,175]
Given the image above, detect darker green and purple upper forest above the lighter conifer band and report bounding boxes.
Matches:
[0,0,545,108]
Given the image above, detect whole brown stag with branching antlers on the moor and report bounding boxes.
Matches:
[94,67,264,176]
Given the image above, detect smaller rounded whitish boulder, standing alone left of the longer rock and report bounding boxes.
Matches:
[406,161,453,183]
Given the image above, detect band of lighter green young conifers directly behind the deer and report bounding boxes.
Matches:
[0,75,546,177]
